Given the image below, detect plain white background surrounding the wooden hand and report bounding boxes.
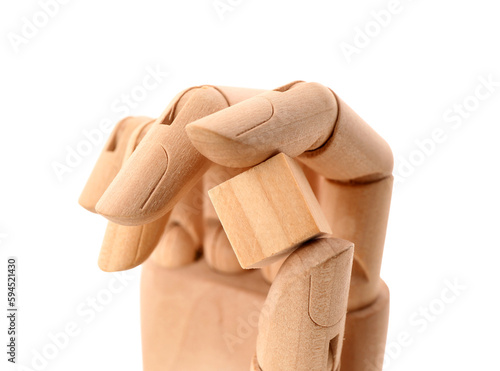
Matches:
[0,0,500,371]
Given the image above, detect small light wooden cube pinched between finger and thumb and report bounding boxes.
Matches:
[208,153,331,268]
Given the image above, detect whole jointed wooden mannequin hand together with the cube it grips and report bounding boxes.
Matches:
[80,82,393,371]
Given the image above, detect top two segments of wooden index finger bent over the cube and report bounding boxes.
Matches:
[186,82,393,182]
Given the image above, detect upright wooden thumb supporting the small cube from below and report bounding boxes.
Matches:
[252,237,353,371]
